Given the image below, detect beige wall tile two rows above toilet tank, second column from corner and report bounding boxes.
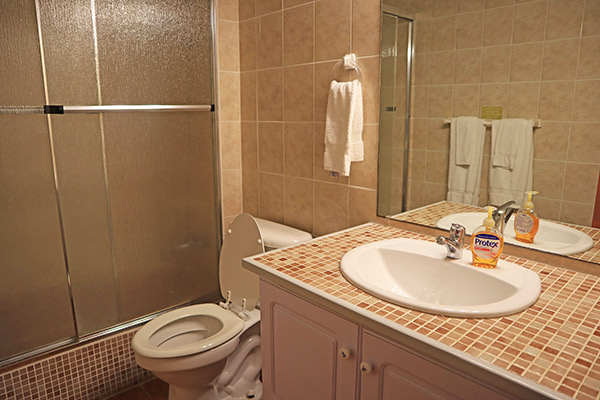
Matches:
[258,122,283,174]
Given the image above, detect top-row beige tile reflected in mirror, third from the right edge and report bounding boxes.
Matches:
[513,0,547,43]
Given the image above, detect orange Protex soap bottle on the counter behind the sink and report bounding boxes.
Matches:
[471,207,504,268]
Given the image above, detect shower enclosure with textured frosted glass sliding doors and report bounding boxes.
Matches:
[0,0,220,366]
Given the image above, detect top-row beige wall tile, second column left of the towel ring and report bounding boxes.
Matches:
[283,4,314,65]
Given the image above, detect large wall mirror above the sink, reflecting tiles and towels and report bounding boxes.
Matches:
[377,0,600,264]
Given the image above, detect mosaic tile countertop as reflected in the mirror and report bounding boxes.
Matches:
[392,201,600,264]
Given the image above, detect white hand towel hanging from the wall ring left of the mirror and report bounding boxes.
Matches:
[323,79,364,176]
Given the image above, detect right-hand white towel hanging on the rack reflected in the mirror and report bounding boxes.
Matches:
[489,119,533,205]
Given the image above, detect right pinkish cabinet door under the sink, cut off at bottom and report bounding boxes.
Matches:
[360,330,508,400]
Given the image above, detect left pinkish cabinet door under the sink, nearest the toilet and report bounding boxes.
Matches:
[260,280,359,400]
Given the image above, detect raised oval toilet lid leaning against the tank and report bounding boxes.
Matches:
[219,214,265,311]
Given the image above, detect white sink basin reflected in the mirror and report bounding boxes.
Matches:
[437,212,594,255]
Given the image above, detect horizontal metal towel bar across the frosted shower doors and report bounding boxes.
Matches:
[0,104,215,115]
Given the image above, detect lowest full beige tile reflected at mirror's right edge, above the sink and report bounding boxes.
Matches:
[563,162,600,204]
